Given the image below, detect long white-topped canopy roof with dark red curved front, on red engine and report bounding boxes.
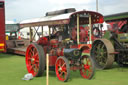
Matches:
[20,11,103,28]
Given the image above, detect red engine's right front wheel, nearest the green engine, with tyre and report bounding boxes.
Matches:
[80,55,95,79]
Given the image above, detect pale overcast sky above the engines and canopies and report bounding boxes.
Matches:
[5,0,128,22]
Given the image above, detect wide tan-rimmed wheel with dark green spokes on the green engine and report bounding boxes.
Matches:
[91,39,114,69]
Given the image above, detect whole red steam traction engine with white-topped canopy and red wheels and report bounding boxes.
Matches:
[21,9,103,82]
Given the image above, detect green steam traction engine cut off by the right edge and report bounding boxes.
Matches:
[91,13,128,69]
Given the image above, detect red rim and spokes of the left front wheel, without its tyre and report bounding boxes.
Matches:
[56,58,67,81]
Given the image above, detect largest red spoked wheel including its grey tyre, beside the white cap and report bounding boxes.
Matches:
[26,43,45,77]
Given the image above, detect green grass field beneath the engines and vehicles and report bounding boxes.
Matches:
[0,54,128,85]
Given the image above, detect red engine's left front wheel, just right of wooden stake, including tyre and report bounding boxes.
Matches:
[55,57,70,82]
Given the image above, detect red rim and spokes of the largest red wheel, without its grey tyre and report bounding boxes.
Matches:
[26,45,39,76]
